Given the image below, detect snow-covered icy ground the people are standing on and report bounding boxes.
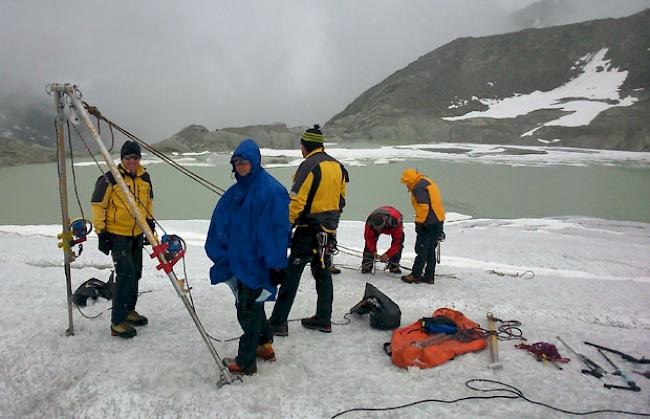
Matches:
[0,216,650,418]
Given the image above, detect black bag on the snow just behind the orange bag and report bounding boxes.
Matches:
[350,282,402,330]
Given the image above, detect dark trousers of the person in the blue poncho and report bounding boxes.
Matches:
[235,280,273,368]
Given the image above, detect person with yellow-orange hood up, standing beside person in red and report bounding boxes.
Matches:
[400,169,445,284]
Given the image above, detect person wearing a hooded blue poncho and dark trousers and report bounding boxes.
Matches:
[205,139,291,375]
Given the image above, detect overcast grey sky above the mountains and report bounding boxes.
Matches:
[0,0,644,141]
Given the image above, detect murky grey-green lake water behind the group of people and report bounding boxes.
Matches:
[0,160,650,224]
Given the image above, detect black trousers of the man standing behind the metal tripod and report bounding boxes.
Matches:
[110,234,143,324]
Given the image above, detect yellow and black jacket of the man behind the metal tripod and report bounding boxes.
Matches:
[91,164,153,236]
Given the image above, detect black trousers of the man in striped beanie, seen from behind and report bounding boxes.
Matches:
[270,227,336,326]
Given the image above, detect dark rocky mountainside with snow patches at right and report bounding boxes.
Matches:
[325,10,650,150]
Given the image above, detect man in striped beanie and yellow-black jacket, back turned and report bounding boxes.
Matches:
[269,125,349,336]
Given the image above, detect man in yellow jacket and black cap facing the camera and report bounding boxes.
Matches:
[91,141,155,338]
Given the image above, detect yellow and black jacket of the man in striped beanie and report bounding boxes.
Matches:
[289,148,349,232]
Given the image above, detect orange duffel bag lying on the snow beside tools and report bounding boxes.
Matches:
[384,308,487,368]
